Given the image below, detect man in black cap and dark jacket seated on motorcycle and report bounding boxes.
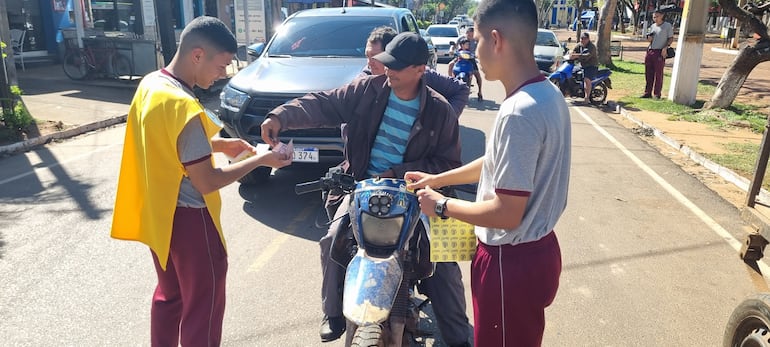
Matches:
[261,32,469,346]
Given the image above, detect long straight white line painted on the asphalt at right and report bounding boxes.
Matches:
[573,107,770,274]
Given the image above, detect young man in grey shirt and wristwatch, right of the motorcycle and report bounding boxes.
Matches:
[404,0,571,347]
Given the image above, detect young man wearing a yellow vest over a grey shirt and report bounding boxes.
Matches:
[112,17,291,346]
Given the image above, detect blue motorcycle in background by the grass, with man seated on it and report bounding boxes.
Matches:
[548,54,612,105]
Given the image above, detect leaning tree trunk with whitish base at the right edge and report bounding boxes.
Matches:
[704,47,770,109]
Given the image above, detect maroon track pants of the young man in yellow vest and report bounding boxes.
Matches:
[151,207,227,347]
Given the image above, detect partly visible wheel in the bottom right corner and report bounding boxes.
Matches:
[722,293,770,347]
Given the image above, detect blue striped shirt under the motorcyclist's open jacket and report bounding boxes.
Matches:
[366,90,420,177]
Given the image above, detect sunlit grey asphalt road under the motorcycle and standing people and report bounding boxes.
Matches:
[0,72,767,347]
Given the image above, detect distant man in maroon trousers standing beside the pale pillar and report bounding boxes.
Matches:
[642,11,674,99]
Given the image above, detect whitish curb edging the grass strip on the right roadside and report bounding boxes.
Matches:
[616,105,770,205]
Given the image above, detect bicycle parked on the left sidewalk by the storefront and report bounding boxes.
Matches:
[62,39,134,81]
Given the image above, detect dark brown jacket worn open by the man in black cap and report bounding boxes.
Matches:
[269,75,462,180]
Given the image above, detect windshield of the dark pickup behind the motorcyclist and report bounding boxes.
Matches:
[267,16,396,57]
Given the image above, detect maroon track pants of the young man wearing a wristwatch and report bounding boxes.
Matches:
[471,232,561,347]
